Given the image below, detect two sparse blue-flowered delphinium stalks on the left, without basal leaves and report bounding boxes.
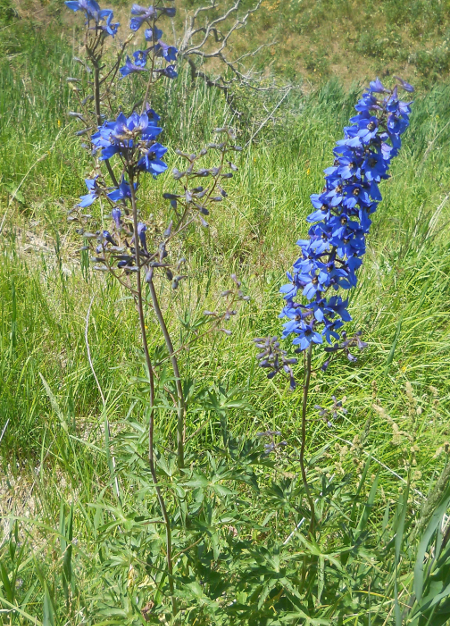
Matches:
[66,0,248,615]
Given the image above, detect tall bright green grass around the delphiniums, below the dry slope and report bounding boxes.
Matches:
[0,19,450,624]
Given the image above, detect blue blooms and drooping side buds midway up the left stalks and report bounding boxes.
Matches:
[68,129,244,280]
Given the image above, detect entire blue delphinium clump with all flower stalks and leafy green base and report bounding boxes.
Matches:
[54,7,450,626]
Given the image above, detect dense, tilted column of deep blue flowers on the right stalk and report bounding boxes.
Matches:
[280,79,413,352]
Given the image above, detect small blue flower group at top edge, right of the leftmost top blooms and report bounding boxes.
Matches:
[120,4,178,78]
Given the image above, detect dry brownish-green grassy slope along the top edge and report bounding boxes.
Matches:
[4,0,450,90]
